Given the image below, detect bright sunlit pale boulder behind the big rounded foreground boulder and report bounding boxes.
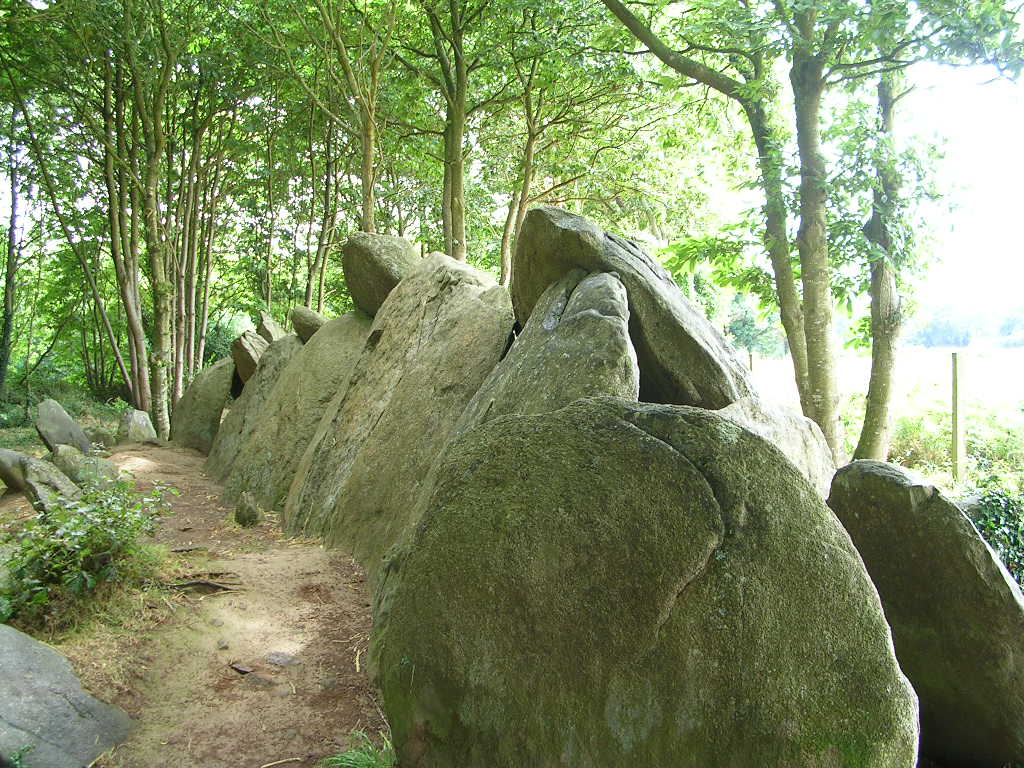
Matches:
[718,397,836,499]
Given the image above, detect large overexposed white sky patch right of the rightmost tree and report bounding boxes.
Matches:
[897,65,1024,321]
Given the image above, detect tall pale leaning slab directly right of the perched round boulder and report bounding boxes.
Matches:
[284,255,512,578]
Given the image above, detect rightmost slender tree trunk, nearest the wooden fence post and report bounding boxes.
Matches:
[853,73,903,461]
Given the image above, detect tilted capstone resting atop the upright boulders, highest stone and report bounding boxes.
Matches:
[512,207,754,409]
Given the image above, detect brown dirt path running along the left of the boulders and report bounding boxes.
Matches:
[70,446,384,768]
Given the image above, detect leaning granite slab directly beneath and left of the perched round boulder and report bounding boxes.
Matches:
[224,311,371,509]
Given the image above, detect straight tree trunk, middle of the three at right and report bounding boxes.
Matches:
[790,47,843,463]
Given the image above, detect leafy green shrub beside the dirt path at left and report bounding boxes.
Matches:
[0,482,165,625]
